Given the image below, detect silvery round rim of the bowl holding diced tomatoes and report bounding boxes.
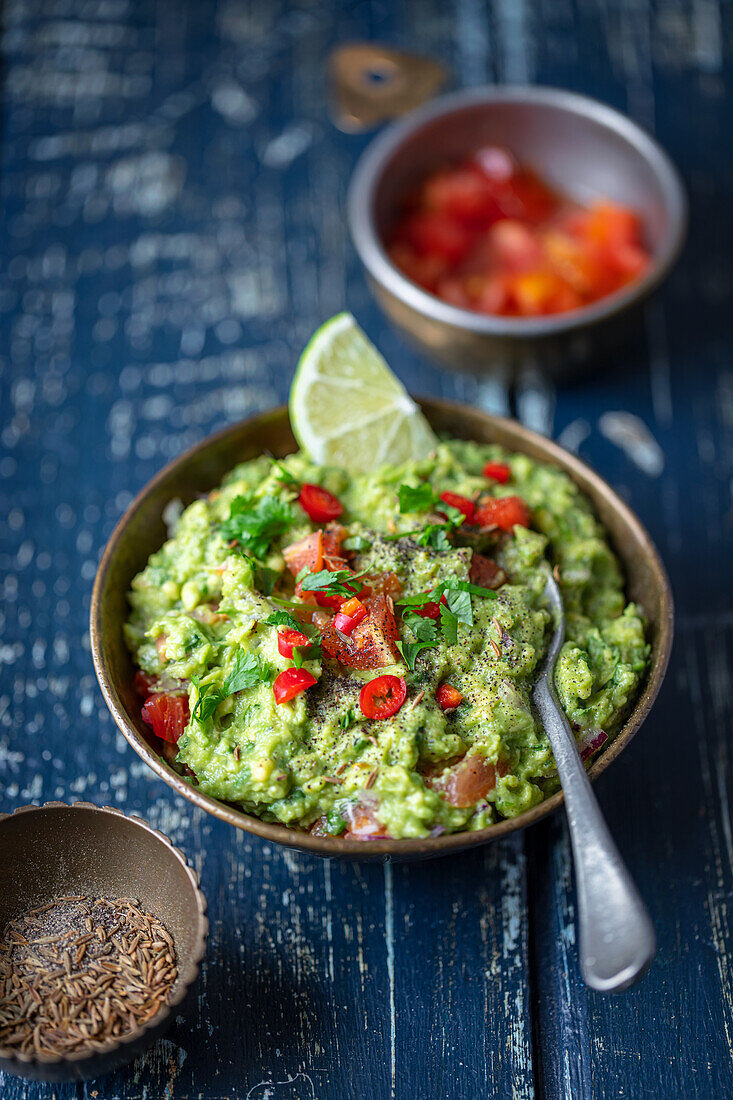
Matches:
[347,85,688,340]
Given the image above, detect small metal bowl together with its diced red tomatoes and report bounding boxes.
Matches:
[349,87,687,373]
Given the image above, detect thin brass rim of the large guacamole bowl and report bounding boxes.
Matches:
[90,398,674,861]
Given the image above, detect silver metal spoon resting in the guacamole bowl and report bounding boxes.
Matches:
[533,575,656,993]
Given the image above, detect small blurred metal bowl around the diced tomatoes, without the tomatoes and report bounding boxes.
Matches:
[348,86,687,375]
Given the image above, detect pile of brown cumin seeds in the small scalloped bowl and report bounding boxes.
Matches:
[0,895,178,1056]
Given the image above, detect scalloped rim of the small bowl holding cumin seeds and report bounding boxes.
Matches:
[0,800,209,1074]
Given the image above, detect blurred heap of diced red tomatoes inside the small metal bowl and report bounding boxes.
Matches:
[386,146,649,317]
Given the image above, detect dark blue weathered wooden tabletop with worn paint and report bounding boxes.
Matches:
[0,0,733,1100]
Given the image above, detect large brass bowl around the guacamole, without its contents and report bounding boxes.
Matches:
[90,400,672,861]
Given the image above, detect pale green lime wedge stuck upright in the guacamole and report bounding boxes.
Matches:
[289,314,437,473]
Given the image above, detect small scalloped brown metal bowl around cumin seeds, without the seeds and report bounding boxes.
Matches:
[0,802,208,1081]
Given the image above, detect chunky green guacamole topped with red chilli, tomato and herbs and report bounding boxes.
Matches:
[125,440,649,839]
